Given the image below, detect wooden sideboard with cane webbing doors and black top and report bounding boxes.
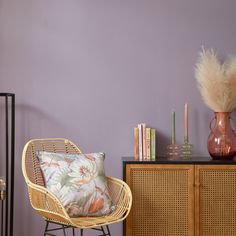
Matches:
[123,157,236,236]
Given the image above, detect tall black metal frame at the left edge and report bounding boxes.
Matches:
[0,93,15,236]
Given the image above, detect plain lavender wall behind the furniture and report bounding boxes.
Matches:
[0,0,236,236]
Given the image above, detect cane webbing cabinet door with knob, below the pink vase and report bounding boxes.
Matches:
[195,165,236,236]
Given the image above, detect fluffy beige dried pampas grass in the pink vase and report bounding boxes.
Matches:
[195,49,236,112]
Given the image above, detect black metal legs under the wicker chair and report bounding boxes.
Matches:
[43,220,111,236]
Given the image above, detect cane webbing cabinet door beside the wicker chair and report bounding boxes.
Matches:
[124,164,194,236]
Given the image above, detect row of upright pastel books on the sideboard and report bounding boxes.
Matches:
[134,123,156,161]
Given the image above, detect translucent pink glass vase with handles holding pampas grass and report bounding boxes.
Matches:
[208,112,236,160]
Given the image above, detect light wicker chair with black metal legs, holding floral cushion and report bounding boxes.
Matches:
[22,138,132,236]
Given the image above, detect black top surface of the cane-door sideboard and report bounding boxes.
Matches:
[122,156,236,165]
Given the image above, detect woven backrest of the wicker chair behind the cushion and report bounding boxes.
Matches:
[22,138,81,186]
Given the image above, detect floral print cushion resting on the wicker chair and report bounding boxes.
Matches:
[37,151,113,217]
